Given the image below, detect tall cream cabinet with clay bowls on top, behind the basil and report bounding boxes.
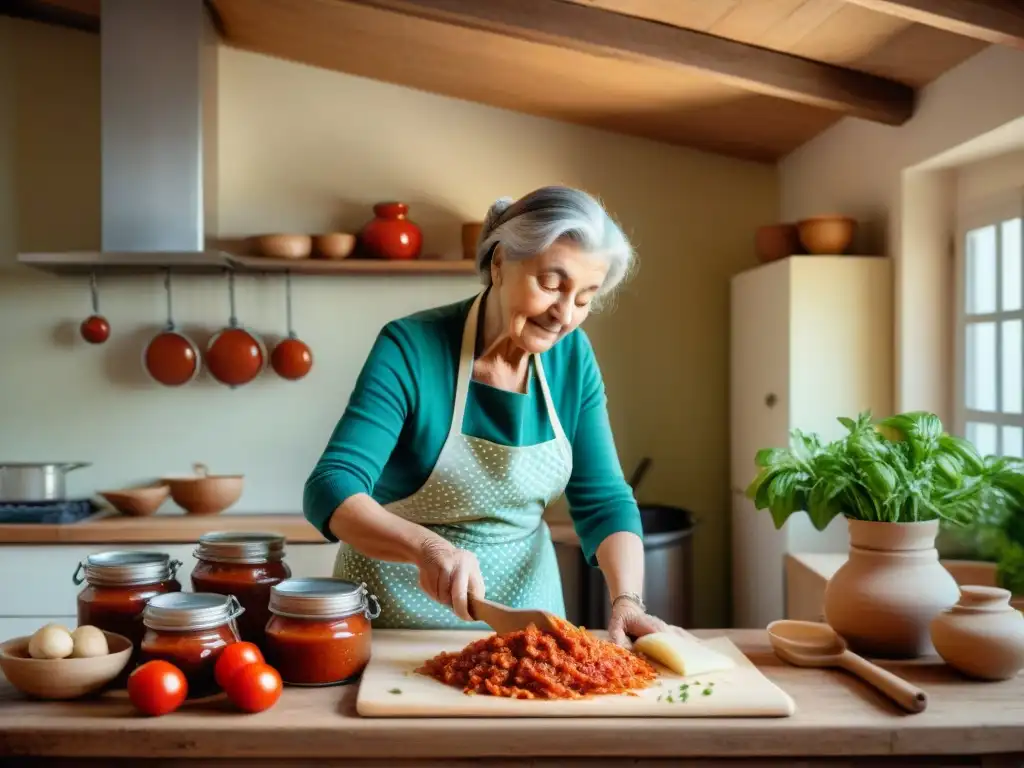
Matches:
[730,256,894,627]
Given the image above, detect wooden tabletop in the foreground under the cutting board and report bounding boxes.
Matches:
[0,630,1024,766]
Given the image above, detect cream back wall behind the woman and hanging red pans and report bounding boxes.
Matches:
[0,18,777,625]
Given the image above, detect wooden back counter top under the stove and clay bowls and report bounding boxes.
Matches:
[0,511,325,545]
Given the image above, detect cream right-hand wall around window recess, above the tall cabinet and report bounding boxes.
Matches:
[779,46,1024,428]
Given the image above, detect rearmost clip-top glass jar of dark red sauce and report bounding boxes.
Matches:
[191,531,292,647]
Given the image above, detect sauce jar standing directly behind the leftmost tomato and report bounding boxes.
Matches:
[139,592,245,698]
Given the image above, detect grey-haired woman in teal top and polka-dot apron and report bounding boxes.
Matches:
[304,186,688,646]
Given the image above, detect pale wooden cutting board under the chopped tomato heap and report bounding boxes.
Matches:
[356,630,796,718]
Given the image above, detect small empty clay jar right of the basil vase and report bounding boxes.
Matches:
[932,586,1024,680]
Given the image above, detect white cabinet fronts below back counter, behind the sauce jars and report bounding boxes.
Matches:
[0,543,338,626]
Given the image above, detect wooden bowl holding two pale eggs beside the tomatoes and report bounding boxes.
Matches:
[0,630,132,699]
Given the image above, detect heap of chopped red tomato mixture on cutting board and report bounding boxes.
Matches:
[418,620,657,698]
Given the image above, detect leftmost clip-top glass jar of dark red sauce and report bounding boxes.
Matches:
[72,551,181,655]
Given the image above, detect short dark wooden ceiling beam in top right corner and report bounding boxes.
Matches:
[847,0,1024,50]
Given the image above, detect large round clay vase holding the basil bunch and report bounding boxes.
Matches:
[824,518,959,658]
